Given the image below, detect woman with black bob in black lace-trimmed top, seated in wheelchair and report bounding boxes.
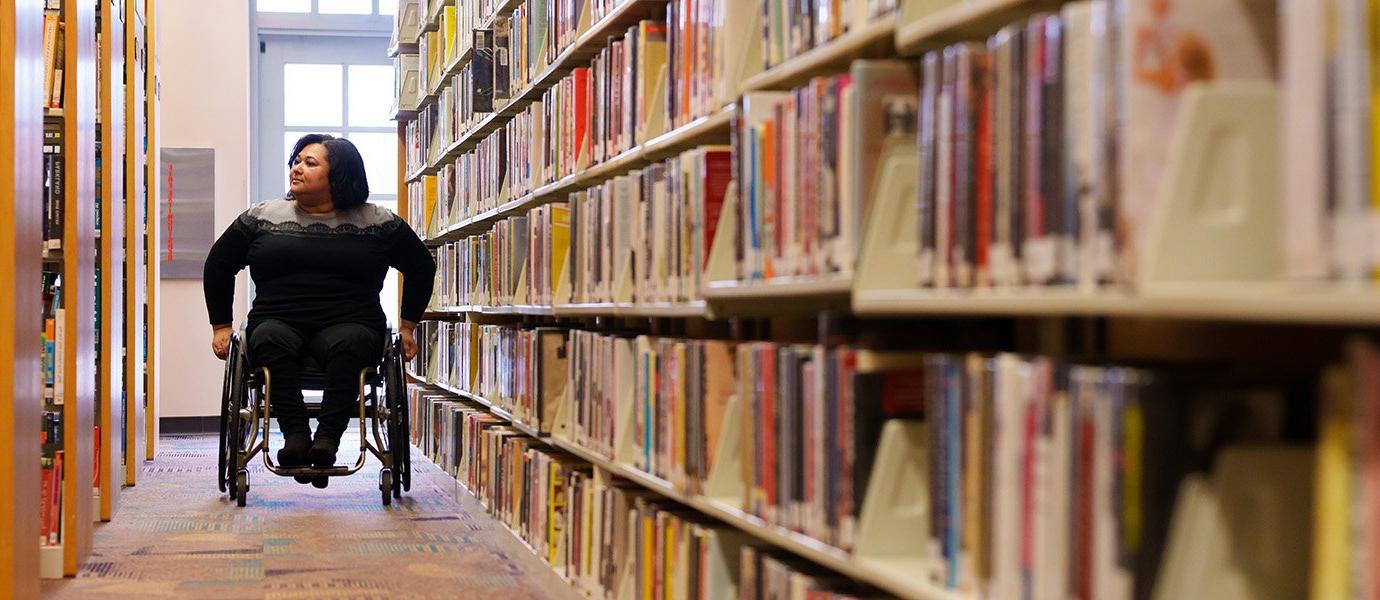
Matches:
[203,134,436,487]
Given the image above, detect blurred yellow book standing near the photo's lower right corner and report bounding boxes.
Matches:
[1310,367,1355,600]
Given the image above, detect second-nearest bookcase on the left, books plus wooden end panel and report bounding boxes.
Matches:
[39,0,99,577]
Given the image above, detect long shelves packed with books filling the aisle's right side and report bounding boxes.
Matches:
[397,0,1380,599]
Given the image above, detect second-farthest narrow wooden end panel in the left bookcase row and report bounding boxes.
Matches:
[124,0,148,486]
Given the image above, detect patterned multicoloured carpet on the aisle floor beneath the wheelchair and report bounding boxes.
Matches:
[43,436,578,600]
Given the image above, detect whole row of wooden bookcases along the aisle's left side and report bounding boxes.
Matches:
[0,0,158,597]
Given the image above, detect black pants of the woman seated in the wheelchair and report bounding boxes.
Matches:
[248,319,384,440]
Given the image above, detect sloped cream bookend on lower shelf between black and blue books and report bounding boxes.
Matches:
[856,421,930,586]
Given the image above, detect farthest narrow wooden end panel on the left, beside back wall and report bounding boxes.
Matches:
[144,0,161,461]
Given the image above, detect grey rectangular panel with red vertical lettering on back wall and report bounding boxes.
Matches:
[157,148,215,279]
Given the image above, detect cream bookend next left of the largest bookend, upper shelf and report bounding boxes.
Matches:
[854,134,920,297]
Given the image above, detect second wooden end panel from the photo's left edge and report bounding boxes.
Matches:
[62,0,95,575]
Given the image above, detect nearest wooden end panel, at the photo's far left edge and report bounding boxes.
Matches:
[0,0,43,599]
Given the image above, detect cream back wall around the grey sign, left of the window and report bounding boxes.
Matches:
[150,0,250,417]
